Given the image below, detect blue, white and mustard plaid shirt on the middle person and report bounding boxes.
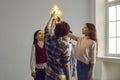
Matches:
[45,28,70,80]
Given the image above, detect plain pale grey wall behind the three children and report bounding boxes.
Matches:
[0,0,90,80]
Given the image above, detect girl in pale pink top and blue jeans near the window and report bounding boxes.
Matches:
[69,23,98,80]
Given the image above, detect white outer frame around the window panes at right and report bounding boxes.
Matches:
[105,0,120,57]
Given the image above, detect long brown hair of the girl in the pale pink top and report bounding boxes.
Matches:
[86,23,98,51]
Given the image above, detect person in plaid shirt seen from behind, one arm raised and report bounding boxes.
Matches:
[45,12,70,80]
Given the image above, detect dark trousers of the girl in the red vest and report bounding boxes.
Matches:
[35,68,46,80]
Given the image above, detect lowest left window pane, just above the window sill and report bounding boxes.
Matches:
[109,38,116,54]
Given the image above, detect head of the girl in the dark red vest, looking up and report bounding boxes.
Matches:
[33,30,44,44]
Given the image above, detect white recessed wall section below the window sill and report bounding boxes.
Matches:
[95,57,120,80]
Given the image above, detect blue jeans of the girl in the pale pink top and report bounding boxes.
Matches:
[77,60,91,80]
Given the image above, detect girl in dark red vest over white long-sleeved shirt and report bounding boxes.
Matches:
[30,30,47,80]
